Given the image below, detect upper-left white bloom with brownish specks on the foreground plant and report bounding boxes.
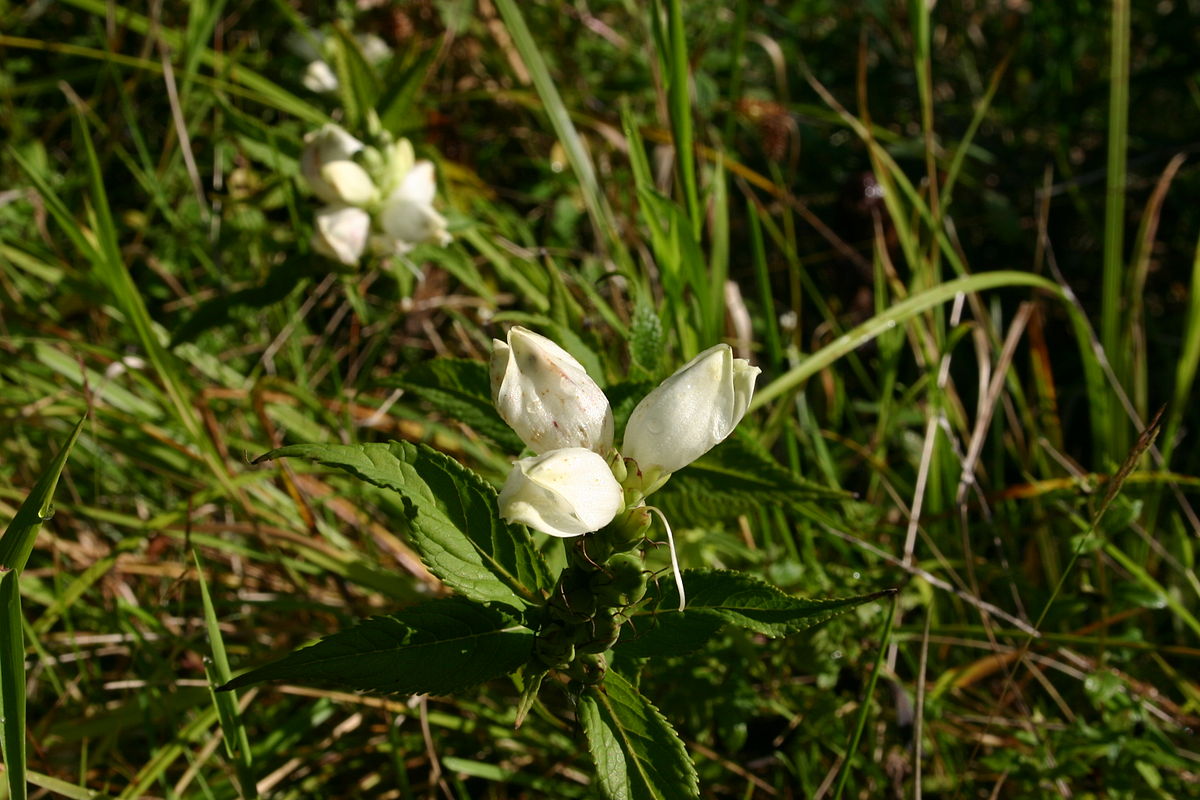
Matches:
[491,326,612,455]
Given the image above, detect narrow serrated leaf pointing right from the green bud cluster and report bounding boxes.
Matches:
[636,570,895,637]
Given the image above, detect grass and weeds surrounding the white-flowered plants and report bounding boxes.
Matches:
[0,0,1200,799]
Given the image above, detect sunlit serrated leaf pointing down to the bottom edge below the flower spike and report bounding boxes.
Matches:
[578,672,700,800]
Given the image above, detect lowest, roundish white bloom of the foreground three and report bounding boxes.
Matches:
[499,447,625,537]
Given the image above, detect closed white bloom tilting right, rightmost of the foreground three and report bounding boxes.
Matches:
[622,344,761,475]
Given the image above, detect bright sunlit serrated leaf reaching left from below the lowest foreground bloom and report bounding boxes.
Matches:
[258,441,553,607]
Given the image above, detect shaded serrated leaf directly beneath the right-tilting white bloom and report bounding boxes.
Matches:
[653,434,850,525]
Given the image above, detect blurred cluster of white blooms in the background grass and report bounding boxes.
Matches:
[300,124,450,266]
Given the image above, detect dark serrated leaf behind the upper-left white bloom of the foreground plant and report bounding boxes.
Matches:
[385,359,524,452]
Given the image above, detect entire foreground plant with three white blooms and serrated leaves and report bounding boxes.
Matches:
[223,327,878,799]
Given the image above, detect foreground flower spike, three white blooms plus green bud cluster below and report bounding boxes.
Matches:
[491,327,758,681]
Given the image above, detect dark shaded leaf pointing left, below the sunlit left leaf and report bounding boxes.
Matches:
[221,597,534,694]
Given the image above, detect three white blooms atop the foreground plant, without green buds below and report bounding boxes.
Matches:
[491,327,760,537]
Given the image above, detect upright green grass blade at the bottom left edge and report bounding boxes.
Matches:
[0,567,29,800]
